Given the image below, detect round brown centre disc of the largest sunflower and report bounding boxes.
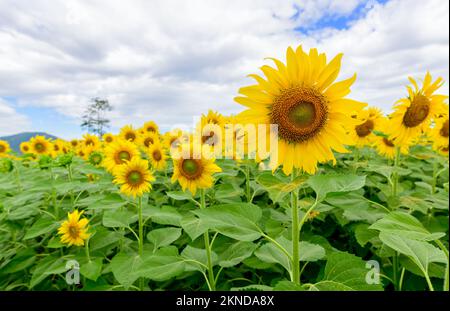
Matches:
[270,87,328,143]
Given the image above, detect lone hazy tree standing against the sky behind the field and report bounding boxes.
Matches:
[81,97,112,137]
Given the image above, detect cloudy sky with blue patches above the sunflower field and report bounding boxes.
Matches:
[0,0,449,139]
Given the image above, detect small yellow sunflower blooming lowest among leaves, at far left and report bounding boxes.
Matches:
[58,210,90,246]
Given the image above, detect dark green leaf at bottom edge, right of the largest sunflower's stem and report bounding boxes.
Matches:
[319,252,383,290]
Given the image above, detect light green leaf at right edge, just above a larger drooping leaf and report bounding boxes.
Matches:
[370,211,445,241]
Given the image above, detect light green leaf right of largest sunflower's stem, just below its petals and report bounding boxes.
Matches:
[307,174,366,200]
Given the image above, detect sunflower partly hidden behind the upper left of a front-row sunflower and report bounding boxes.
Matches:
[103,139,139,172]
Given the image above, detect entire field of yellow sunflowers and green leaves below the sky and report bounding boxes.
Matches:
[0,46,449,291]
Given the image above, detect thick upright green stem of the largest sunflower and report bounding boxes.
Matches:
[291,169,300,284]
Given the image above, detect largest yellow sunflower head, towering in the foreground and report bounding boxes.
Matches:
[235,46,366,175]
